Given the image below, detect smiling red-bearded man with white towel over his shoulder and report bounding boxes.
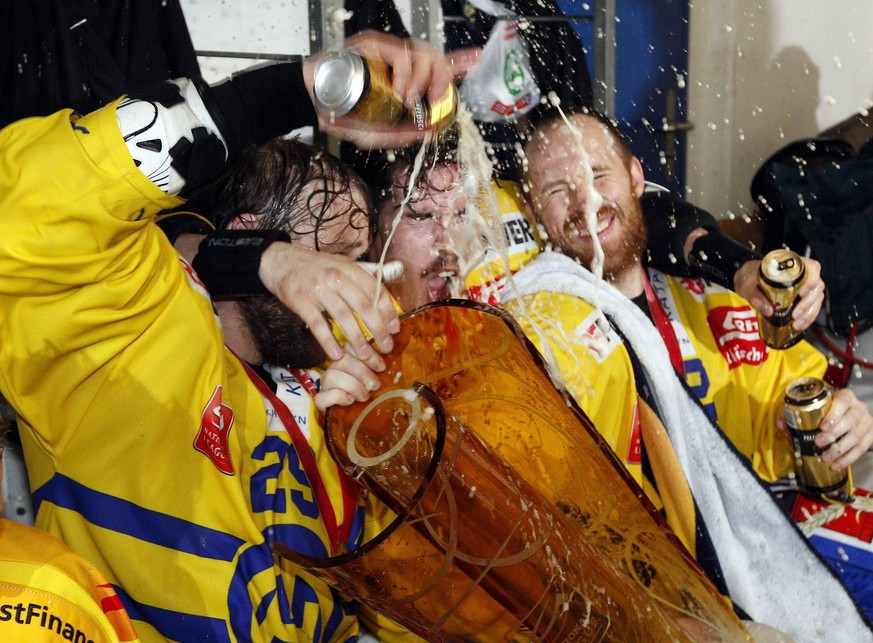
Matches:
[504,112,873,640]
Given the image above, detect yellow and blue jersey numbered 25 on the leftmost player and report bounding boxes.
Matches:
[0,104,398,642]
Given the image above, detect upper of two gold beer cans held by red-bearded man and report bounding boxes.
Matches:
[758,250,806,349]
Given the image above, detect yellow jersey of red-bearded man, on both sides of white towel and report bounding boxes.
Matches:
[506,270,826,488]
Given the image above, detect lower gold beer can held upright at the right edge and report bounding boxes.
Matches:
[784,377,854,502]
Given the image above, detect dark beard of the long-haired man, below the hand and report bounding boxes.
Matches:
[239,296,327,368]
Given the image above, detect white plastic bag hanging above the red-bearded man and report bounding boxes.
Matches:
[460,0,540,122]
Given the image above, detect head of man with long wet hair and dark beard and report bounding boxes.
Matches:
[187,139,375,368]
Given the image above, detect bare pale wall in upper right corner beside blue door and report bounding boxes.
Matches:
[688,0,873,223]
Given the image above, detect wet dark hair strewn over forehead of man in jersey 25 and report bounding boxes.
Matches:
[210,138,375,250]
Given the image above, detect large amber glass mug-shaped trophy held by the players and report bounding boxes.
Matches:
[277,300,750,641]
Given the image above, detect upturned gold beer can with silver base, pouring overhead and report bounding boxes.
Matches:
[313,51,458,131]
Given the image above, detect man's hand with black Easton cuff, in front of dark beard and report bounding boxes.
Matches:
[258,242,400,360]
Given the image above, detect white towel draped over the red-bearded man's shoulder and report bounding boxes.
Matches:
[502,252,873,642]
